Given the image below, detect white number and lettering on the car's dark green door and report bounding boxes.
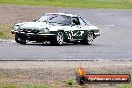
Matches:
[67,31,84,39]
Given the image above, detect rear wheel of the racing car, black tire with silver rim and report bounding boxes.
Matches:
[82,31,94,45]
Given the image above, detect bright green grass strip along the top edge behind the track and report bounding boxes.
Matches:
[0,0,132,9]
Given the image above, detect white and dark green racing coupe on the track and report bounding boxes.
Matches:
[11,13,100,45]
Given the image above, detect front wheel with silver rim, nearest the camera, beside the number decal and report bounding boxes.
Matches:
[51,31,64,46]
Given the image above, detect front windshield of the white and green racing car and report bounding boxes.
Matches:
[38,14,71,25]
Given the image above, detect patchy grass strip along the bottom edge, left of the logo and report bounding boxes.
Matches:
[0,79,82,88]
